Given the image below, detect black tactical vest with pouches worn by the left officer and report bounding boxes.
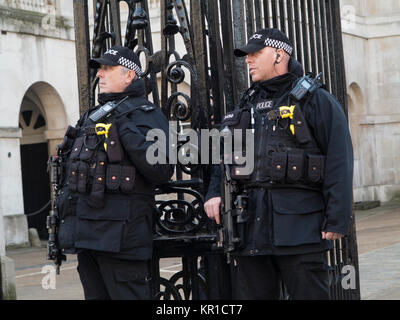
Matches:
[59,100,154,208]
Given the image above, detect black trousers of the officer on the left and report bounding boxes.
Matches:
[78,251,151,300]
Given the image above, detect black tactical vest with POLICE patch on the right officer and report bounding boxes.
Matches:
[222,84,325,190]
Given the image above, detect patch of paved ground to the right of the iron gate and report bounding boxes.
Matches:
[356,200,400,300]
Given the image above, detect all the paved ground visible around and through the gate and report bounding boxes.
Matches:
[7,200,400,300]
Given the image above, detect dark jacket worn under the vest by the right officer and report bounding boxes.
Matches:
[206,60,353,255]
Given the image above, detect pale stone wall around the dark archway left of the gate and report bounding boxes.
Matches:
[0,0,79,246]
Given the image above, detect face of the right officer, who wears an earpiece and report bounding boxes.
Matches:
[246,47,278,82]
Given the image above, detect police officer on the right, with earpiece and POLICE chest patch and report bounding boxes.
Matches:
[204,29,353,299]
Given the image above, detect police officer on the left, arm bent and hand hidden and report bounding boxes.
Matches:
[56,46,173,300]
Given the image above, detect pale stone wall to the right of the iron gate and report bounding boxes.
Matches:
[341,0,400,201]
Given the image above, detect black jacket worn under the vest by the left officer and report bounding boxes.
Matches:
[56,80,173,260]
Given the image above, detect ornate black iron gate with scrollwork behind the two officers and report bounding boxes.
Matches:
[74,0,360,299]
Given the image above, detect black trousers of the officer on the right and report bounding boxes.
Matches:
[231,252,330,300]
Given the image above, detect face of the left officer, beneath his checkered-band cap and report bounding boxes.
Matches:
[97,65,133,93]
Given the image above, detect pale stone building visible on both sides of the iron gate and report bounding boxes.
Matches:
[0,0,400,255]
